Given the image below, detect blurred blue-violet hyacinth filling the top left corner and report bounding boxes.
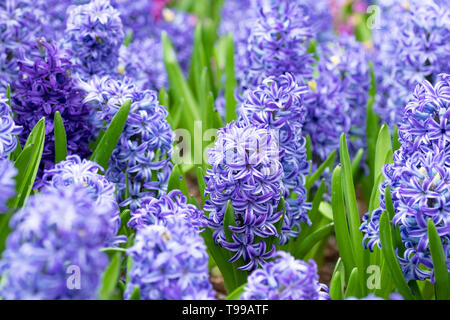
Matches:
[0,0,44,93]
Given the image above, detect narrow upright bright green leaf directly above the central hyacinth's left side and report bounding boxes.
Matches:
[225,34,237,123]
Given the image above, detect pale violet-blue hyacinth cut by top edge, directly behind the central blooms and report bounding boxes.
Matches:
[235,0,314,98]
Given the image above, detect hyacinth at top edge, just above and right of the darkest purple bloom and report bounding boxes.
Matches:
[65,0,125,79]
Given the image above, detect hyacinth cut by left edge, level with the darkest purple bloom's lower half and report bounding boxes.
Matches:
[0,96,21,160]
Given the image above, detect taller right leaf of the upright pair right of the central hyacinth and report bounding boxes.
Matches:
[339,133,368,294]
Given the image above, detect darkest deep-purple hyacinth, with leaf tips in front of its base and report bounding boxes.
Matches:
[12,39,92,182]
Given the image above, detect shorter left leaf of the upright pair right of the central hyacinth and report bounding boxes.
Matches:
[331,165,356,280]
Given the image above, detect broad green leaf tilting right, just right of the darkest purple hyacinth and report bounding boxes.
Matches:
[90,99,131,171]
